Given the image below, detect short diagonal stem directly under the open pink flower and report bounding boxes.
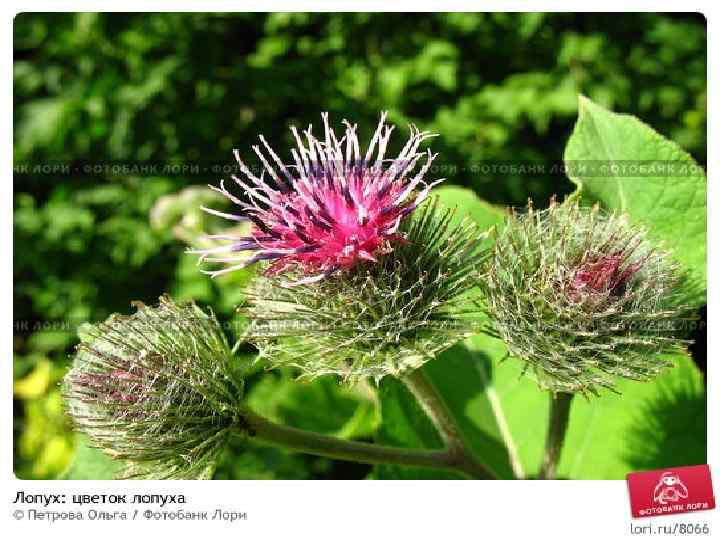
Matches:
[402,368,496,478]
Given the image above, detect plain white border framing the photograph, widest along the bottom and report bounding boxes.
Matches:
[0,0,720,540]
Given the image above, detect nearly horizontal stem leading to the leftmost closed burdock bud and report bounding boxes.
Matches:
[243,411,464,474]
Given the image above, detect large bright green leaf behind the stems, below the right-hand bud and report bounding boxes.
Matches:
[374,326,707,480]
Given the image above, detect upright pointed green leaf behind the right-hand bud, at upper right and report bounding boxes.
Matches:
[564,96,707,304]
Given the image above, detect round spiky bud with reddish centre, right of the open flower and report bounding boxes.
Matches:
[480,202,684,393]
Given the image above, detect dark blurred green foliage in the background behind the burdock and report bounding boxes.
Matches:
[13,13,706,478]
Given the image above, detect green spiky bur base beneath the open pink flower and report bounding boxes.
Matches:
[246,201,487,382]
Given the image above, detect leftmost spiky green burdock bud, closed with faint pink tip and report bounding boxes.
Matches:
[63,297,242,478]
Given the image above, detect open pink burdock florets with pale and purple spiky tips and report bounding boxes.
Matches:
[191,113,443,285]
